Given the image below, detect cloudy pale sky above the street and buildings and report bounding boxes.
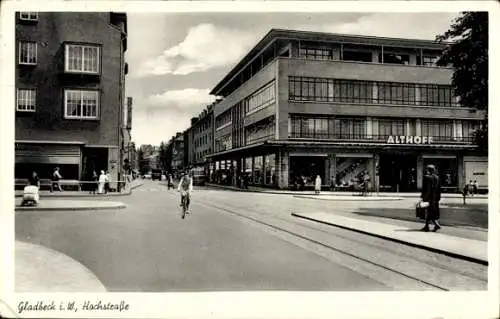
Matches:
[126,12,459,145]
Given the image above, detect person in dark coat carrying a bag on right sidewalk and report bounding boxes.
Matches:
[420,165,441,231]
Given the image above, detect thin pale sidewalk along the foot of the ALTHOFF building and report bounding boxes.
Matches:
[206,183,488,200]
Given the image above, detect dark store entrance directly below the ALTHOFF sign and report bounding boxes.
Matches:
[379,154,417,192]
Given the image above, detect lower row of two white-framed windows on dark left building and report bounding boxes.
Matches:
[16,89,99,119]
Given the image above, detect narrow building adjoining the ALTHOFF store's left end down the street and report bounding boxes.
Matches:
[184,101,219,175]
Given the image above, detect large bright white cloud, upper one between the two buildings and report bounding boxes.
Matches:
[138,23,258,77]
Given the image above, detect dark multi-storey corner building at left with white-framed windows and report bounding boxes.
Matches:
[15,12,131,188]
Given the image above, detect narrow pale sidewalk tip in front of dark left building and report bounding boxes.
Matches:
[15,198,127,211]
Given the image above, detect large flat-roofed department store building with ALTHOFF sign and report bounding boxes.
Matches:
[210,29,488,191]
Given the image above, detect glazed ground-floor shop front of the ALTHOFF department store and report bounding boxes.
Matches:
[209,147,488,192]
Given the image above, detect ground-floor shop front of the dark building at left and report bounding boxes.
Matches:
[14,142,122,188]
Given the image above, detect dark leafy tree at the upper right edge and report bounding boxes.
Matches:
[436,12,488,151]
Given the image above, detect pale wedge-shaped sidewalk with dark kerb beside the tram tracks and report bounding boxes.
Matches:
[292,212,488,265]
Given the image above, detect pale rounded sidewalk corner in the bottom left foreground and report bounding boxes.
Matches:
[15,241,106,293]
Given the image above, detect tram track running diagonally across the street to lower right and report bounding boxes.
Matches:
[162,188,487,291]
